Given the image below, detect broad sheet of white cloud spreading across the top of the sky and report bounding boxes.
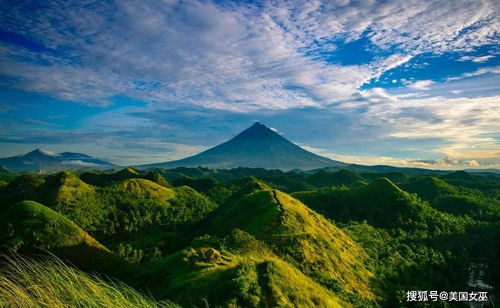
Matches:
[0,0,498,112]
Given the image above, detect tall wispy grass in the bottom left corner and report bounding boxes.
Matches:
[0,256,177,308]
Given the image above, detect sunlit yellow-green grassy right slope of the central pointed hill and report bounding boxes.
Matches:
[270,191,375,300]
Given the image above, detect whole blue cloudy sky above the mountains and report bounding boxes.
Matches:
[0,0,500,169]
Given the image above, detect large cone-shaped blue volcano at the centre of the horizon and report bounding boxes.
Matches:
[138,122,347,170]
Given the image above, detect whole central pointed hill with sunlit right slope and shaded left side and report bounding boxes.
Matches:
[195,182,374,299]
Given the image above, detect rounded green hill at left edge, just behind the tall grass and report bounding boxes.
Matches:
[0,201,135,279]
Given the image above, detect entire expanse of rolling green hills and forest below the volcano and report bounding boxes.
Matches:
[0,167,500,307]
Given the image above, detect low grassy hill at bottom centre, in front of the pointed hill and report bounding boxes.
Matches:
[146,231,348,307]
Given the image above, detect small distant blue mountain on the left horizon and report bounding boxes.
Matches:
[0,149,117,172]
